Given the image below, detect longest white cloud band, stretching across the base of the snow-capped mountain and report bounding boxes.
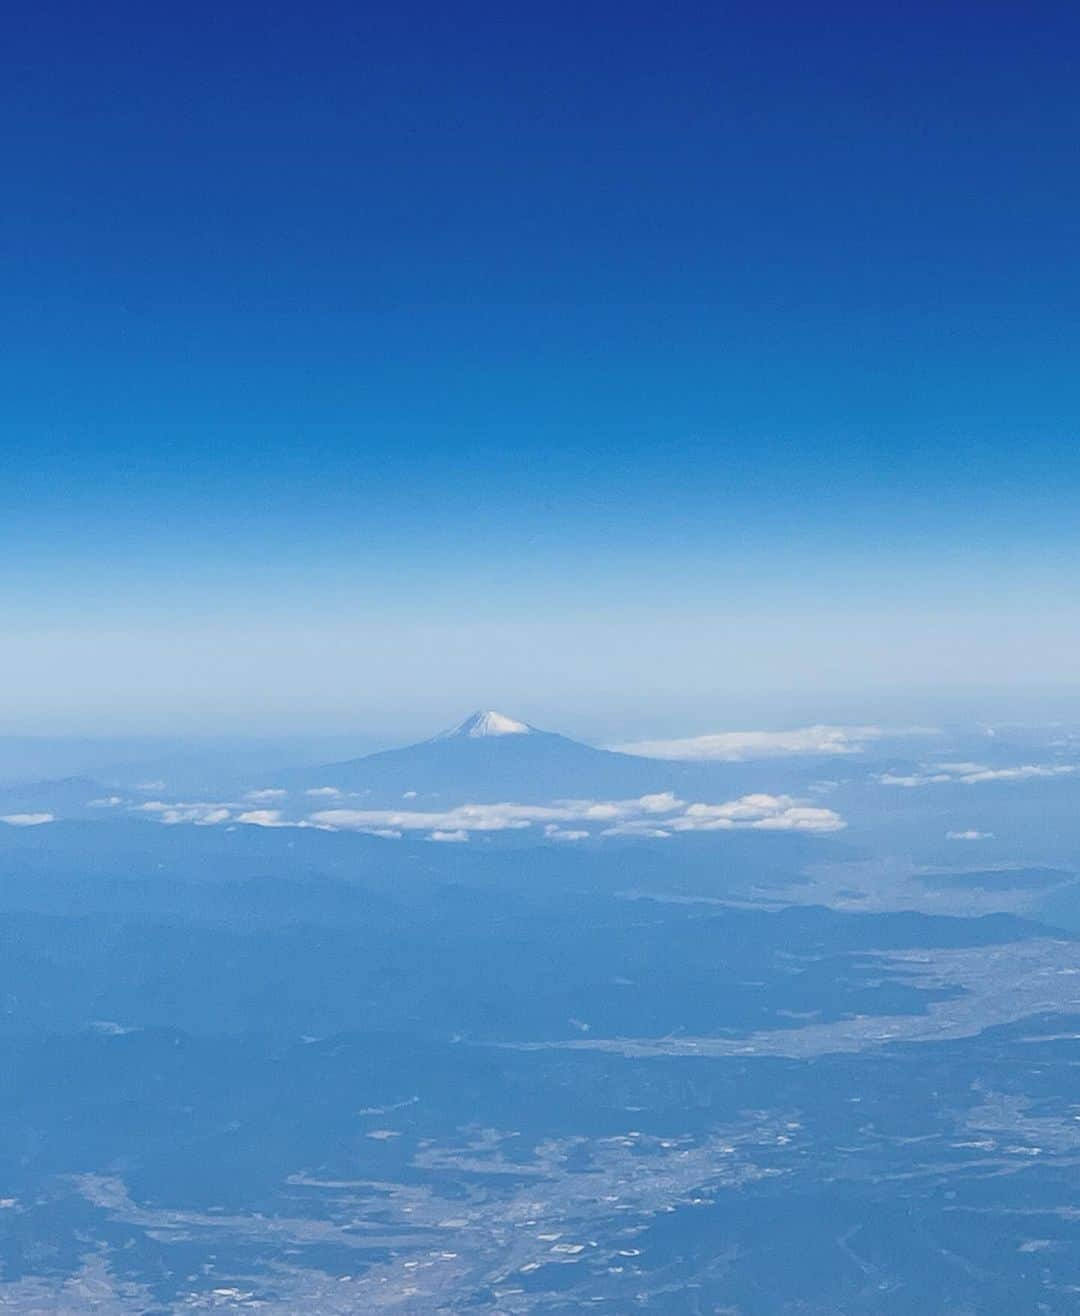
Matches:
[312,792,845,841]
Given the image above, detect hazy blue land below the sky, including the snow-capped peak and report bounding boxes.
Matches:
[0,715,1080,1316]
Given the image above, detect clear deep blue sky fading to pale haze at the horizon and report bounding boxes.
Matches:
[0,4,1080,733]
